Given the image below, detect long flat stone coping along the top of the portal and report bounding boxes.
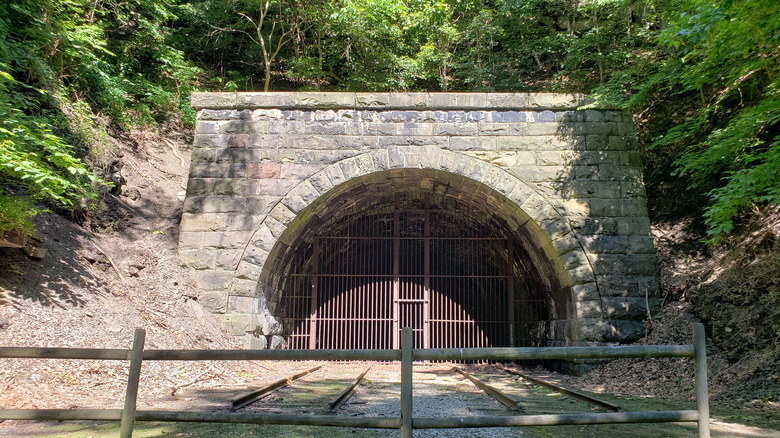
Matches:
[190,91,594,110]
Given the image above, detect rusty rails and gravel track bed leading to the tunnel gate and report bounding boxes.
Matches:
[229,363,619,422]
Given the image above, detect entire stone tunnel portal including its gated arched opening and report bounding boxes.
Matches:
[179,92,660,348]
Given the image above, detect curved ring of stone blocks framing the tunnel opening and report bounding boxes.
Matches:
[230,146,601,344]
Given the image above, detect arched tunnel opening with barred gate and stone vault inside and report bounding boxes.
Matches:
[260,169,572,349]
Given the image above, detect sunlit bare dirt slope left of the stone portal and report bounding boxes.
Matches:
[0,124,258,408]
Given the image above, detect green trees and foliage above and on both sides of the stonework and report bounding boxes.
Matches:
[0,0,780,241]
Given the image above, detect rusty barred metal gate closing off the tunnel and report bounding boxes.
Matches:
[282,205,515,349]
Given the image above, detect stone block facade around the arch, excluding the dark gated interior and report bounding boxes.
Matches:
[179,92,660,348]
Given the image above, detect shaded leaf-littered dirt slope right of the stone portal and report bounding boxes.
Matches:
[583,219,780,417]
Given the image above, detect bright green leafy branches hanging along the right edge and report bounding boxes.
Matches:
[648,0,780,243]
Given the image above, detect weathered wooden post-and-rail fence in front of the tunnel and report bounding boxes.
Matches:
[0,323,710,438]
